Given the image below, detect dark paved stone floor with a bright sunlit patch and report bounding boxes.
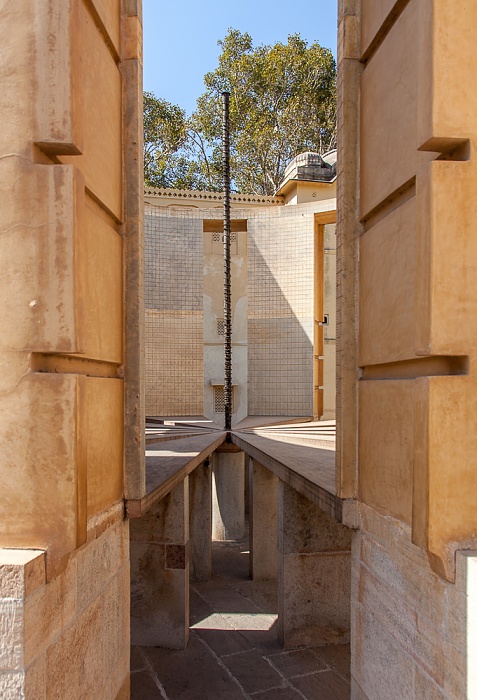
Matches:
[131,540,350,700]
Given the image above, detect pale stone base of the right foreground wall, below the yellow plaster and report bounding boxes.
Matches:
[351,506,470,700]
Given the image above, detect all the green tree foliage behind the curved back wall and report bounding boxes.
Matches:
[145,29,336,194]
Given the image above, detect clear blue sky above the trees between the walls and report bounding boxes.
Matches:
[143,0,337,114]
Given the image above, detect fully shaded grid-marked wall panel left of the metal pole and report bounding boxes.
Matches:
[144,207,204,416]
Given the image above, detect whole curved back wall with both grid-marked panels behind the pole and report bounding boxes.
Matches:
[145,190,336,423]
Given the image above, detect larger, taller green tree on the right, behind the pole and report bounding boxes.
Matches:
[192,29,336,194]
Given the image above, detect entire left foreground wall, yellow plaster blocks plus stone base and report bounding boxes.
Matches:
[0,0,143,699]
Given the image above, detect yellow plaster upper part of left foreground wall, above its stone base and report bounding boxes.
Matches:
[0,0,142,577]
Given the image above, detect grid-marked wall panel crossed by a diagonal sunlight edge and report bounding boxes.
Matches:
[248,207,314,416]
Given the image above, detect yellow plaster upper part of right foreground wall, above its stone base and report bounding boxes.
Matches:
[338,0,477,580]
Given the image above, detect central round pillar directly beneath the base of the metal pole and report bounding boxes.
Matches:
[212,445,245,540]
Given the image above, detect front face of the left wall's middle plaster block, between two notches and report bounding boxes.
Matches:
[0,162,84,352]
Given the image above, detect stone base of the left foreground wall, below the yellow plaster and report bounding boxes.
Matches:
[0,506,129,700]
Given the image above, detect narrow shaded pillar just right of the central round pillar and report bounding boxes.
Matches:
[249,458,278,581]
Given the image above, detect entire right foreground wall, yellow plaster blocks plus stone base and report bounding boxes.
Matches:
[338,0,477,699]
